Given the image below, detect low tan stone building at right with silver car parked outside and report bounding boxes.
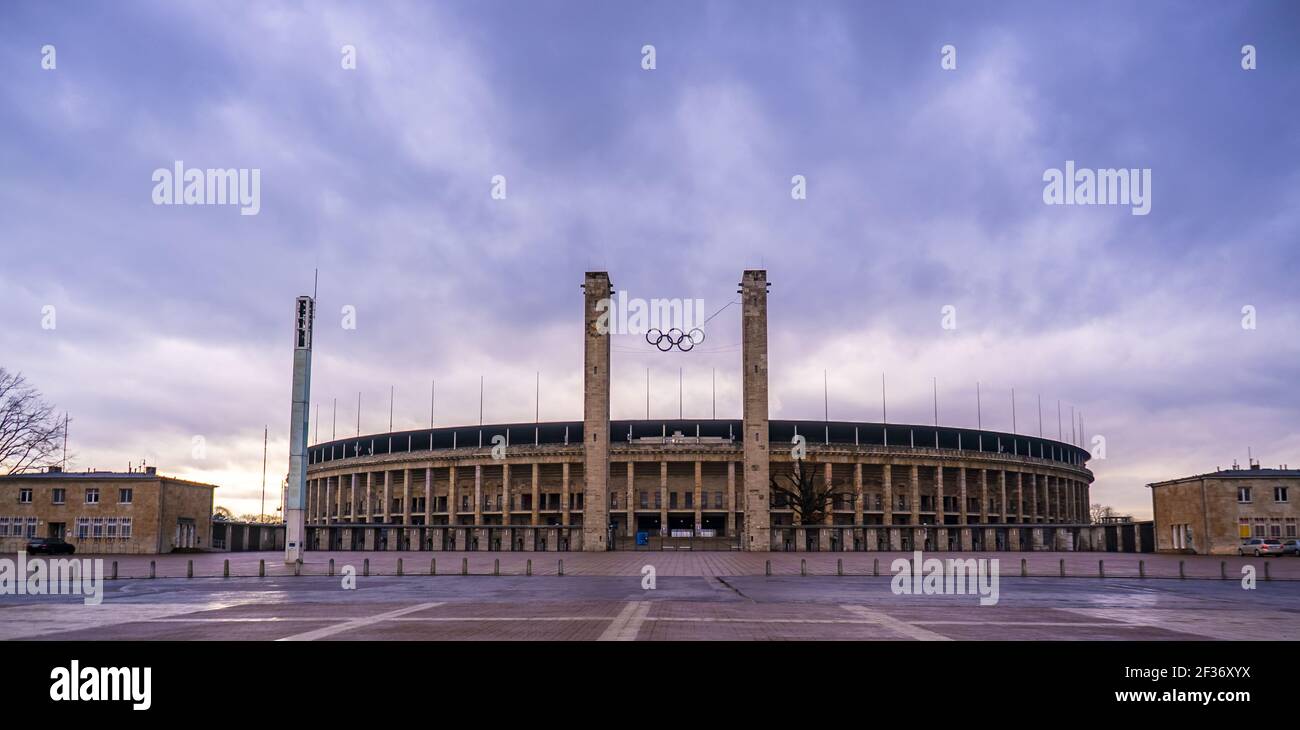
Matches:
[1147,464,1300,555]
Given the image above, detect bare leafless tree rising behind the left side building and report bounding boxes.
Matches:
[0,368,66,474]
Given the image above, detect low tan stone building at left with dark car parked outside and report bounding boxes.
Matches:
[0,466,216,553]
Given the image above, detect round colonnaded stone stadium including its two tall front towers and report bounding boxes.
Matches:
[299,270,1092,551]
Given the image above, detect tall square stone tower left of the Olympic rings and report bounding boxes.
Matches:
[582,271,614,552]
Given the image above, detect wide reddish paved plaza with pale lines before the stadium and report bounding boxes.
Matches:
[0,552,1300,640]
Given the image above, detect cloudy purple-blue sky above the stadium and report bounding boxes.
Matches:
[0,1,1300,517]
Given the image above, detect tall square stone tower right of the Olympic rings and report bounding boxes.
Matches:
[740,270,772,551]
